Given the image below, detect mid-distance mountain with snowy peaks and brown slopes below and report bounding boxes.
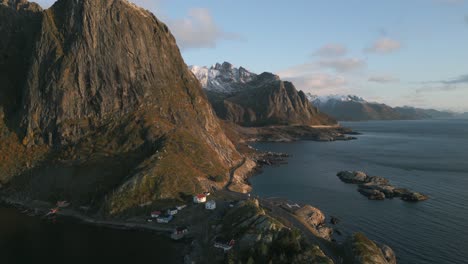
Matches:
[190,62,336,126]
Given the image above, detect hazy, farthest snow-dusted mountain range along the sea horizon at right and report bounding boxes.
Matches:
[307,94,453,121]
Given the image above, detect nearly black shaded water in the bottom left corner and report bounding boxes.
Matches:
[0,205,183,264]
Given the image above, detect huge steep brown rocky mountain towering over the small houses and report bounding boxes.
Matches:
[0,0,241,213]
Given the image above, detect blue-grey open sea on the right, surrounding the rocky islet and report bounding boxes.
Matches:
[251,120,468,264]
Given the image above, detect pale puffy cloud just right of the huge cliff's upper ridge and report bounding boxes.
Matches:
[167,8,242,49]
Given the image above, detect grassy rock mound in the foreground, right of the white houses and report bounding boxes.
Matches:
[220,200,333,264]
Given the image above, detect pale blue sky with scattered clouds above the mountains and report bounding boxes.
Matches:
[37,0,468,111]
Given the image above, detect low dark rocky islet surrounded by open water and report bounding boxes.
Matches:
[337,171,429,202]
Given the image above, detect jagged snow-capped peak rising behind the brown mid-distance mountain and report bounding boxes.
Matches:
[189,62,258,93]
